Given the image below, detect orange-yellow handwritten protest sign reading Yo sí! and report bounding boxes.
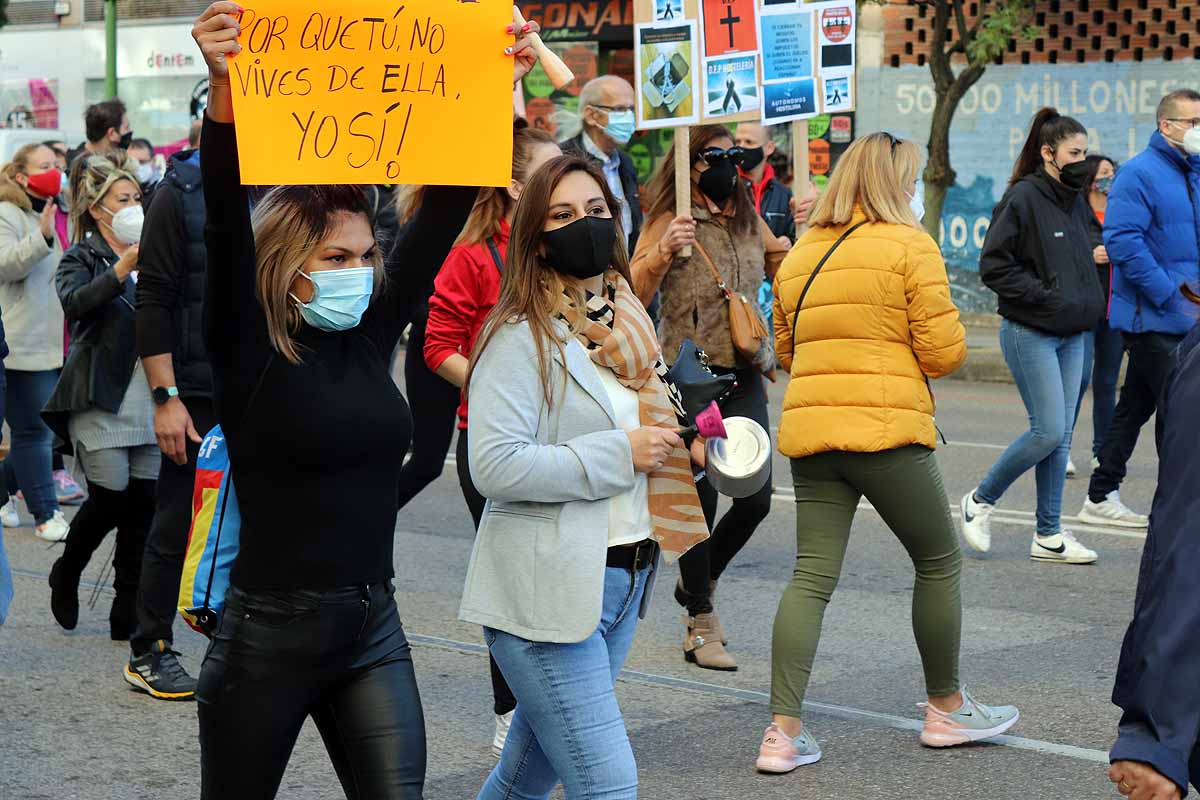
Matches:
[229,0,512,186]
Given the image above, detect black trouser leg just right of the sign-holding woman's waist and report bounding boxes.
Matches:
[398,318,460,509]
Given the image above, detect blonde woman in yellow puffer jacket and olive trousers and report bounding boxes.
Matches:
[757,133,1018,772]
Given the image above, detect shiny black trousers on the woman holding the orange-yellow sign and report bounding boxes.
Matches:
[196,581,425,800]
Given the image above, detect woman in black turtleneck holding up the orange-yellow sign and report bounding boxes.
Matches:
[192,2,536,800]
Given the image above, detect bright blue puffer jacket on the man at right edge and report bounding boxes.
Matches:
[1104,131,1200,336]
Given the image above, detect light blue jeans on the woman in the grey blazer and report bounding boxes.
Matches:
[479,567,650,800]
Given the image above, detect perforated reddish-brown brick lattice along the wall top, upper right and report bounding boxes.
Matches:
[883,0,1200,67]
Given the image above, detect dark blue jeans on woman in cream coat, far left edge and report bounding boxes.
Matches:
[5,369,59,525]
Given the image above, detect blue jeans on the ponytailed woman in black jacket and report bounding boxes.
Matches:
[976,319,1084,536]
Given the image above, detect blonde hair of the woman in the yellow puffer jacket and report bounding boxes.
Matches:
[809,133,920,228]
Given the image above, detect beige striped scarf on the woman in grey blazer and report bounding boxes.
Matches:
[560,270,708,563]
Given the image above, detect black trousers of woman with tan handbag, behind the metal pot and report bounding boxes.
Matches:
[679,367,773,615]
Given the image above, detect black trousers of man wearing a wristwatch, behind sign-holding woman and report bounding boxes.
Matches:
[130,397,217,655]
